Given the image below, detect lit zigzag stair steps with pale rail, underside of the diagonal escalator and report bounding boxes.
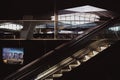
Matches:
[35,39,110,80]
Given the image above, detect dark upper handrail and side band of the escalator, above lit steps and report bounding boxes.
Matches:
[5,19,116,80]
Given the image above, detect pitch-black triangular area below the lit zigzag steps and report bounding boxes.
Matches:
[54,41,120,80]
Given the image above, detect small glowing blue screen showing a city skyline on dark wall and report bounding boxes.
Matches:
[2,48,24,64]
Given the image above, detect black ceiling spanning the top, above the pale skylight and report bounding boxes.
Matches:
[0,0,120,19]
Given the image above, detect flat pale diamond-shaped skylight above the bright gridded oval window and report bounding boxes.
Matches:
[65,5,107,12]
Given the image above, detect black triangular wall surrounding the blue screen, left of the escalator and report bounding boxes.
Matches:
[0,40,68,80]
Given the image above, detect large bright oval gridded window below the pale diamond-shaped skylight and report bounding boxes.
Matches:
[51,13,100,25]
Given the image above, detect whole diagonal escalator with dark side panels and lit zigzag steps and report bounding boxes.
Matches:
[4,18,119,80]
